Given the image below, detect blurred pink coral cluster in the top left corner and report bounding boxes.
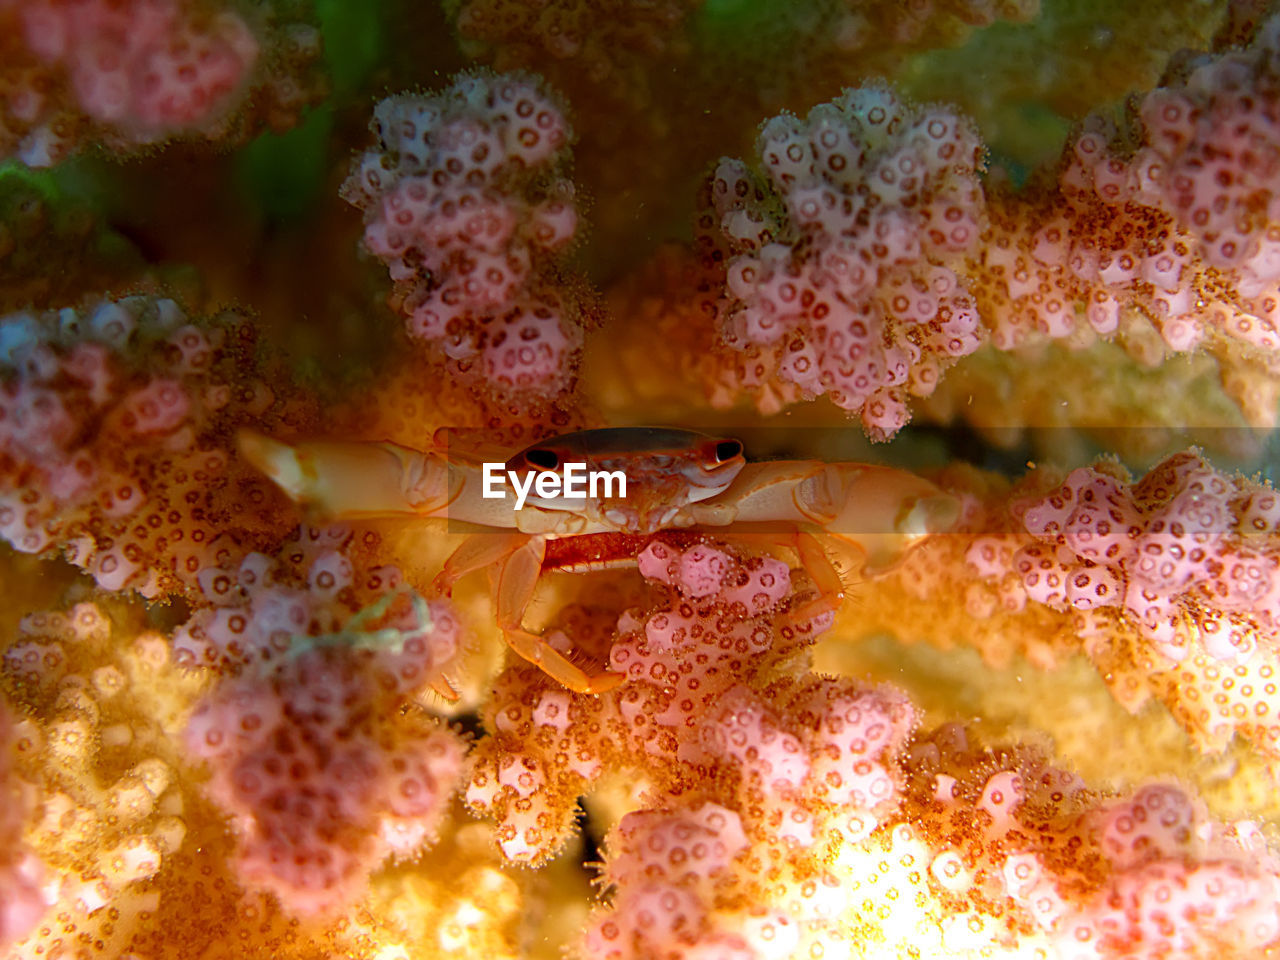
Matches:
[0,0,320,166]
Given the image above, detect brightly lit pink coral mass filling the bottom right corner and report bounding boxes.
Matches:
[833,726,1280,957]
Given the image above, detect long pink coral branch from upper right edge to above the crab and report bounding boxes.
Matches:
[599,18,1280,439]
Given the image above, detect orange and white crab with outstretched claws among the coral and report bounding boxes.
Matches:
[239,428,959,694]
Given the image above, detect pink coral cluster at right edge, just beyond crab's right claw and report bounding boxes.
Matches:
[1012,453,1280,663]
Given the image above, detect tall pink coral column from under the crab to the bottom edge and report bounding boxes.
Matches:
[582,543,914,959]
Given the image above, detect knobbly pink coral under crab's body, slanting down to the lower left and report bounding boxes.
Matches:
[466,541,834,861]
